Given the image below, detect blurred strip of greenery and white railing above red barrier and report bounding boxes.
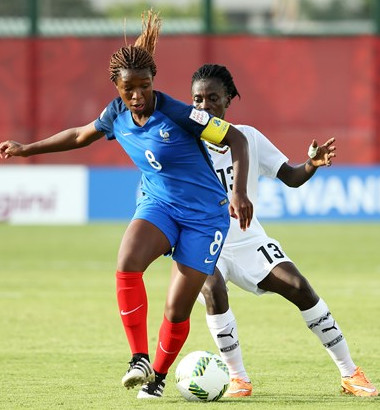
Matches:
[0,0,379,36]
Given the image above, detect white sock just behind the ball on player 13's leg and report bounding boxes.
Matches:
[206,309,249,381]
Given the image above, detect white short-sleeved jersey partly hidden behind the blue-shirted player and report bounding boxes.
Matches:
[206,125,288,247]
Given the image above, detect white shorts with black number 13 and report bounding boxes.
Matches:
[216,236,292,295]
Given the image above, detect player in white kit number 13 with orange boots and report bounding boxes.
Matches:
[191,64,378,397]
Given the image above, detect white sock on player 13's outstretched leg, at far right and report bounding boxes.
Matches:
[301,299,356,377]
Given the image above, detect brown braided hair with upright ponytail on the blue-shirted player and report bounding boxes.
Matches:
[109,10,161,83]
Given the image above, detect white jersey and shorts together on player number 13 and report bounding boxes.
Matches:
[206,125,291,295]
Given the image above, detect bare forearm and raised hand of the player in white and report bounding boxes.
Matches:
[277,138,336,188]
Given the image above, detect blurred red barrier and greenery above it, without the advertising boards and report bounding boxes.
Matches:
[0,0,380,166]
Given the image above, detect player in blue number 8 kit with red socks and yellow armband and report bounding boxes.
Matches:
[0,11,253,399]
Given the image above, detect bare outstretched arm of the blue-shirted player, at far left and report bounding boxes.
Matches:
[0,122,104,159]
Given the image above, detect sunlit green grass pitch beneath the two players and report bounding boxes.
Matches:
[0,223,380,410]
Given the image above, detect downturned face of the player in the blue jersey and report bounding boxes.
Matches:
[116,68,154,117]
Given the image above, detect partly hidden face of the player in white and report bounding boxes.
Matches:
[191,78,231,118]
